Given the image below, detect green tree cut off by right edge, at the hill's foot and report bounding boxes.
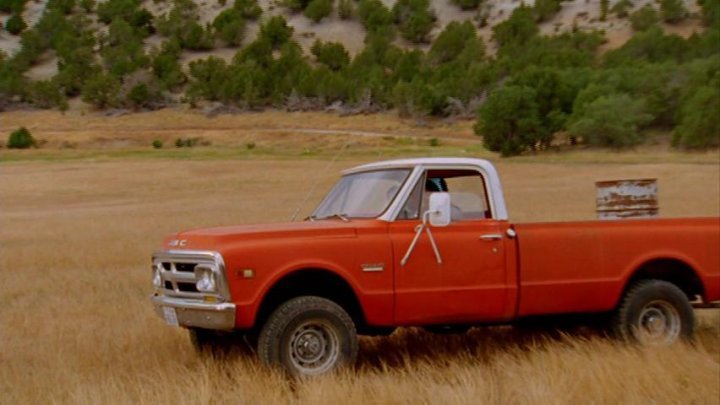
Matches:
[673,85,720,149]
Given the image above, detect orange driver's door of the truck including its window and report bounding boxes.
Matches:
[389,169,514,325]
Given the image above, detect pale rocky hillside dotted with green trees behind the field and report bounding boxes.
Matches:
[0,0,720,154]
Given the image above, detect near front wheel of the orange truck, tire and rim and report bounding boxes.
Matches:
[257,296,358,377]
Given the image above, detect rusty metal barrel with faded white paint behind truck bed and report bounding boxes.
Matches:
[595,179,660,219]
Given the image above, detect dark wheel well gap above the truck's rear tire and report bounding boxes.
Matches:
[623,259,705,301]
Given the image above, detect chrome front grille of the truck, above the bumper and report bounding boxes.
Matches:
[153,250,227,300]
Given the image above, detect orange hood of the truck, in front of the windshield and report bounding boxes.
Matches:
[163,220,361,250]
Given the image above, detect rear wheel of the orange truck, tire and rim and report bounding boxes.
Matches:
[611,280,695,346]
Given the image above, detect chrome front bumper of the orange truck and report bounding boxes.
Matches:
[150,295,235,330]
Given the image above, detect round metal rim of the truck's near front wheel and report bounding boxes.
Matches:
[288,321,340,375]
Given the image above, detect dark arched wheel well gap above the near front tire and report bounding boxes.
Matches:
[255,269,365,328]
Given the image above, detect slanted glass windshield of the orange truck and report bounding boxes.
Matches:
[310,169,410,219]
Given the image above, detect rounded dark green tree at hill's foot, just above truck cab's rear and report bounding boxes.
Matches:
[474,86,542,156]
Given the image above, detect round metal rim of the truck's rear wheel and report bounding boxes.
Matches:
[636,301,681,345]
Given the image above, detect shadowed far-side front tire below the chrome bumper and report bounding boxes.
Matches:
[188,328,257,356]
